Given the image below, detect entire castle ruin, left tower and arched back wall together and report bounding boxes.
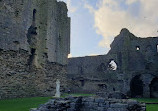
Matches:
[0,0,158,99]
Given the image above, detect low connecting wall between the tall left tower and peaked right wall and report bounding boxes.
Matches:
[68,55,124,93]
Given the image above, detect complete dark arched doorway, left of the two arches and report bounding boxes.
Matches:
[130,75,143,97]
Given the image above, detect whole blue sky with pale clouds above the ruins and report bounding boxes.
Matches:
[58,0,158,57]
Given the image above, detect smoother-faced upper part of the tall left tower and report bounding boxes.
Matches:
[0,0,70,67]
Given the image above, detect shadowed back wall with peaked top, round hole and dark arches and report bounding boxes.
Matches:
[67,29,158,98]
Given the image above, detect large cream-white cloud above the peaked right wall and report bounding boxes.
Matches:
[85,0,158,47]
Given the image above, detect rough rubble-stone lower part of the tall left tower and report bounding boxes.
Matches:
[0,50,67,99]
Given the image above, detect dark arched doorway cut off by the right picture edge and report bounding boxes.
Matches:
[150,78,158,98]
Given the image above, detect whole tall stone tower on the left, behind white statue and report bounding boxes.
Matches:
[0,0,70,99]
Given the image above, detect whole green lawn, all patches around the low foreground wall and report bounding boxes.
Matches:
[0,94,158,111]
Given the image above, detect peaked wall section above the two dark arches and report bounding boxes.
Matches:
[108,29,158,72]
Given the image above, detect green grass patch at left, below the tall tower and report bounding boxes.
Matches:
[0,97,50,111]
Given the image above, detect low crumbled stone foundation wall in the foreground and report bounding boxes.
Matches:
[31,97,146,111]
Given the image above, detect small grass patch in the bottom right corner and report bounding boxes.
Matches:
[136,98,158,111]
